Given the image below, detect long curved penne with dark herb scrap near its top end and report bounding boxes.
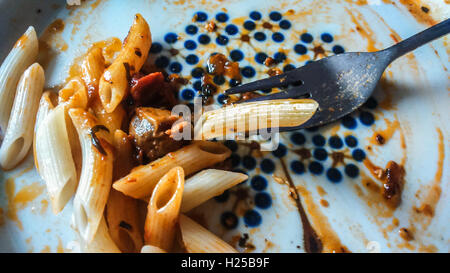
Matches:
[69,108,113,243]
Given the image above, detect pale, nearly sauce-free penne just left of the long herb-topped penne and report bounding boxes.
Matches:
[36,105,78,214]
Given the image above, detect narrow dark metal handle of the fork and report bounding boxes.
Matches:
[383,19,450,62]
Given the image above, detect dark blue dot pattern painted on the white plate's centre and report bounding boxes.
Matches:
[150,10,378,230]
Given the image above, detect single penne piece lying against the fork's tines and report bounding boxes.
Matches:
[195,99,318,140]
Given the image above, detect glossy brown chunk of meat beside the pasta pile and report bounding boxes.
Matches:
[129,107,183,161]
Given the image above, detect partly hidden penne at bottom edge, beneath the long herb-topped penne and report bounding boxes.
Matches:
[80,217,121,253]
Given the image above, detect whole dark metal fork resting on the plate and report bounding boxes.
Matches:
[225,19,450,132]
